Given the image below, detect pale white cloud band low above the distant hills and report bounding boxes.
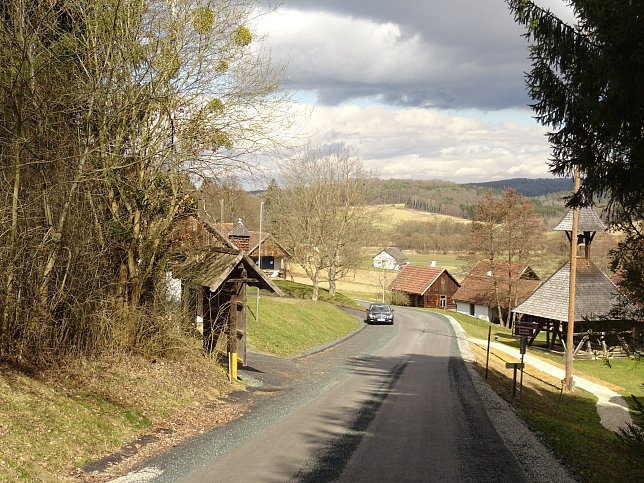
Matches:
[294,105,550,182]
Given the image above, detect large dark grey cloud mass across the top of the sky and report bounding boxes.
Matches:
[262,0,540,110]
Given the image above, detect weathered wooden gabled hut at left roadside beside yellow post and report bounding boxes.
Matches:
[168,212,283,364]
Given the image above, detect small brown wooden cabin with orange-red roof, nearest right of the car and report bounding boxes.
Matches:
[388,264,460,308]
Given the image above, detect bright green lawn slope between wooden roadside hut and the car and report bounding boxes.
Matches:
[247,296,361,357]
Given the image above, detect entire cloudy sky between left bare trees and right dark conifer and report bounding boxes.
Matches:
[254,0,572,182]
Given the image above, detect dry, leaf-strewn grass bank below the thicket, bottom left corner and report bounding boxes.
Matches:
[0,356,230,482]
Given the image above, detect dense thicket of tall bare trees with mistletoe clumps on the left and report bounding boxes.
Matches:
[0,0,290,362]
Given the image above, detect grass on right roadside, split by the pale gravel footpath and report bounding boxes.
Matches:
[442,312,644,482]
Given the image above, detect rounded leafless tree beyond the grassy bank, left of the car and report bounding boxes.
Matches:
[266,146,374,300]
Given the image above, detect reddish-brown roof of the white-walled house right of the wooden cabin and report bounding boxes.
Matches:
[454,260,541,307]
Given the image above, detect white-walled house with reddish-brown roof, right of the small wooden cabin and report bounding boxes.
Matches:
[454,260,540,322]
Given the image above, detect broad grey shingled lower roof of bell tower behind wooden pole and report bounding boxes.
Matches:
[514,260,620,322]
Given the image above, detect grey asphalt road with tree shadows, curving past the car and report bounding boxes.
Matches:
[123,308,526,482]
